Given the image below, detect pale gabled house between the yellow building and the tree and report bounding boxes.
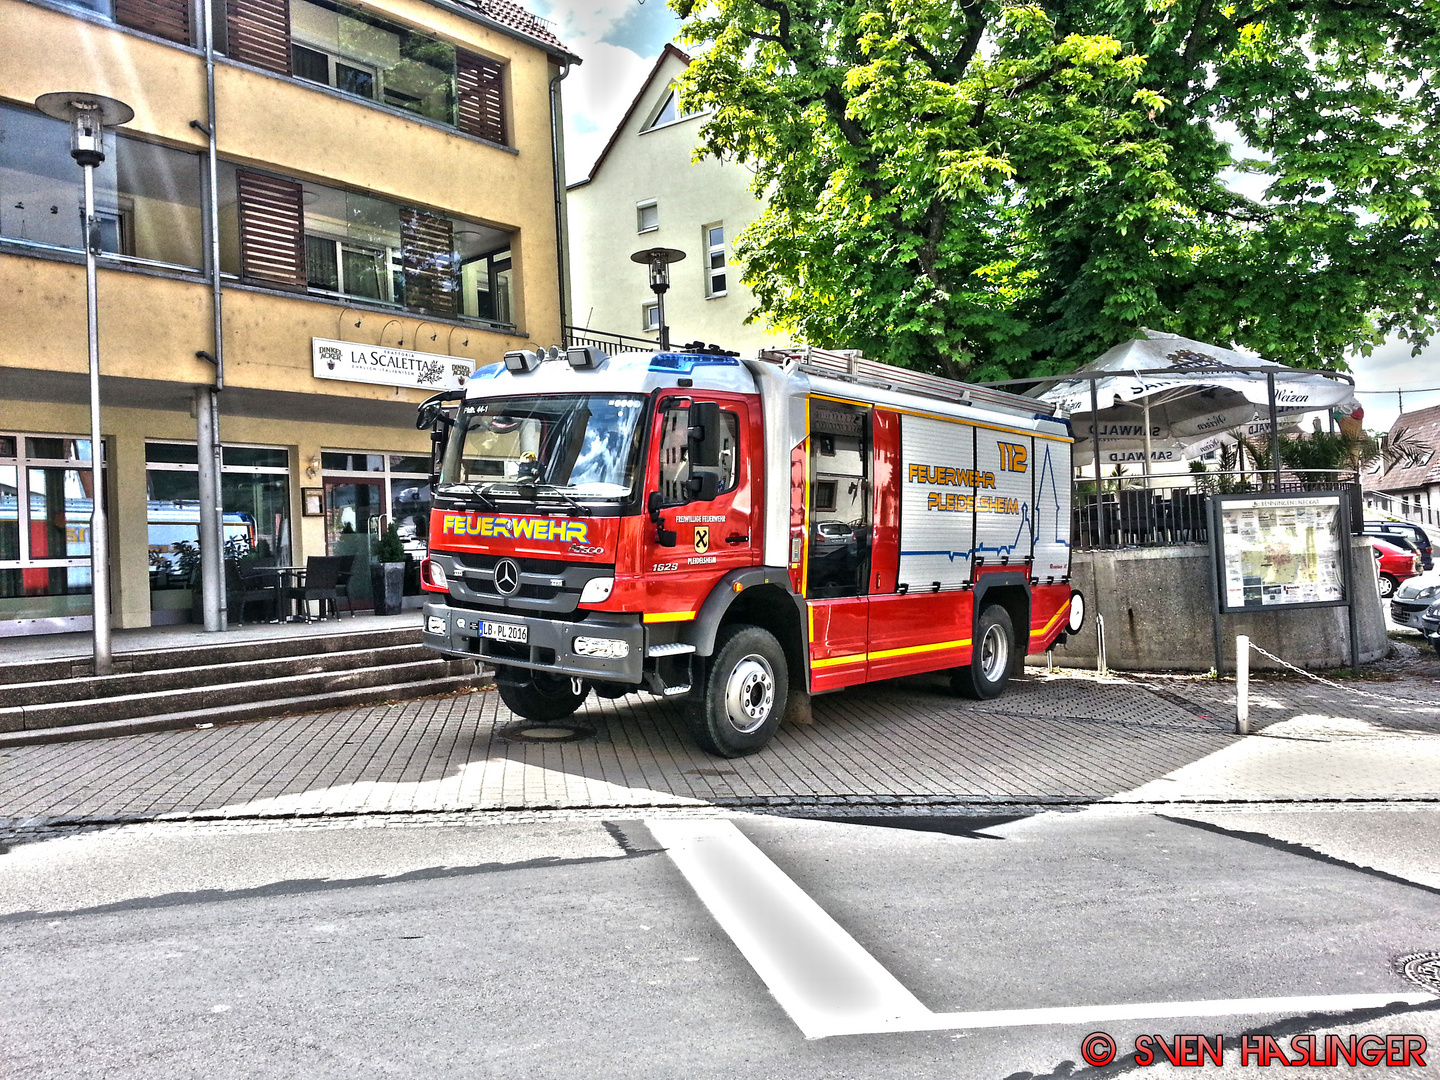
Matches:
[569,45,791,353]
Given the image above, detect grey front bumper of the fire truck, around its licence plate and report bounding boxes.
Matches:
[422,598,645,685]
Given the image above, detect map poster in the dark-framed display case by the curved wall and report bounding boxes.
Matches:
[1211,491,1349,613]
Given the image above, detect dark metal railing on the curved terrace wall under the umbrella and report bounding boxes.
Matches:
[1071,469,1361,552]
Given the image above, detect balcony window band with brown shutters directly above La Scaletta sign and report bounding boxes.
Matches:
[220,163,514,328]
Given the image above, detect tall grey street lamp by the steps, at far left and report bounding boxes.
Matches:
[35,92,135,675]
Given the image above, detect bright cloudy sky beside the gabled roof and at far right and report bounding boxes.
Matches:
[530,0,1440,429]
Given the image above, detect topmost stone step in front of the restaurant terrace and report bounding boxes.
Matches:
[0,625,420,693]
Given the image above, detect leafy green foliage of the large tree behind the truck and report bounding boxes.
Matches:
[671,0,1440,379]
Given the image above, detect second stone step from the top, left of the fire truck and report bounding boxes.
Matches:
[0,642,436,707]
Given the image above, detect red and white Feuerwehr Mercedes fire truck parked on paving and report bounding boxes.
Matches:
[418,346,1083,757]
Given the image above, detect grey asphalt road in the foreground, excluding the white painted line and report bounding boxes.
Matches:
[0,805,1440,1080]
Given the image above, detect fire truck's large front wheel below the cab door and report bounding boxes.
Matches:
[688,622,791,757]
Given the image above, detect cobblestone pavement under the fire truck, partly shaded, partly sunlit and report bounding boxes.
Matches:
[0,670,1440,834]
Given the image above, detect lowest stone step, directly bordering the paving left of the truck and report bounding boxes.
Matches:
[0,673,488,746]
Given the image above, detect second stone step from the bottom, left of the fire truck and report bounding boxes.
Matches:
[0,657,474,732]
